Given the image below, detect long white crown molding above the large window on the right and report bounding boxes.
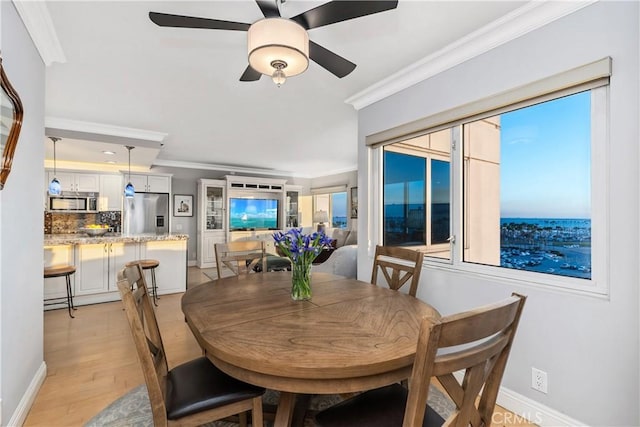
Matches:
[345,0,598,110]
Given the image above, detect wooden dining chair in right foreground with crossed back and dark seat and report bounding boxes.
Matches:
[316,294,526,427]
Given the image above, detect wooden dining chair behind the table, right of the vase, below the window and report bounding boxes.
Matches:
[371,245,424,297]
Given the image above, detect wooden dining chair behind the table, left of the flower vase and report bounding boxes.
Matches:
[215,240,267,278]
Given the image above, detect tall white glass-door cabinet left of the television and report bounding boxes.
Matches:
[196,179,227,268]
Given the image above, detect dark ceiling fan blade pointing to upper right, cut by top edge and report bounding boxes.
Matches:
[291,0,398,30]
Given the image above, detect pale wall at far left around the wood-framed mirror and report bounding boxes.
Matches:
[0,1,44,425]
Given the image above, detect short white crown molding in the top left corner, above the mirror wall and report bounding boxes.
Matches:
[13,0,67,67]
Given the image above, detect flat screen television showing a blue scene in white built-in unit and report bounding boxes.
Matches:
[229,197,280,230]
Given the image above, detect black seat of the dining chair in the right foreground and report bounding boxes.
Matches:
[316,384,444,427]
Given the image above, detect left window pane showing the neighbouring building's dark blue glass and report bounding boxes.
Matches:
[383,129,451,259]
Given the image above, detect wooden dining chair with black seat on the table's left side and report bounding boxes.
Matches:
[118,264,265,427]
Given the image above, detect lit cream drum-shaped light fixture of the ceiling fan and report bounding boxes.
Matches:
[247,18,309,78]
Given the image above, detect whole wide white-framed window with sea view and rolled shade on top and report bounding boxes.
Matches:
[366,58,611,294]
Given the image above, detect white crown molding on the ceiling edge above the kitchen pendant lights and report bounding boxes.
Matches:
[44,117,168,148]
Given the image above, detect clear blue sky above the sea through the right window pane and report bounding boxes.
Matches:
[500,92,591,218]
